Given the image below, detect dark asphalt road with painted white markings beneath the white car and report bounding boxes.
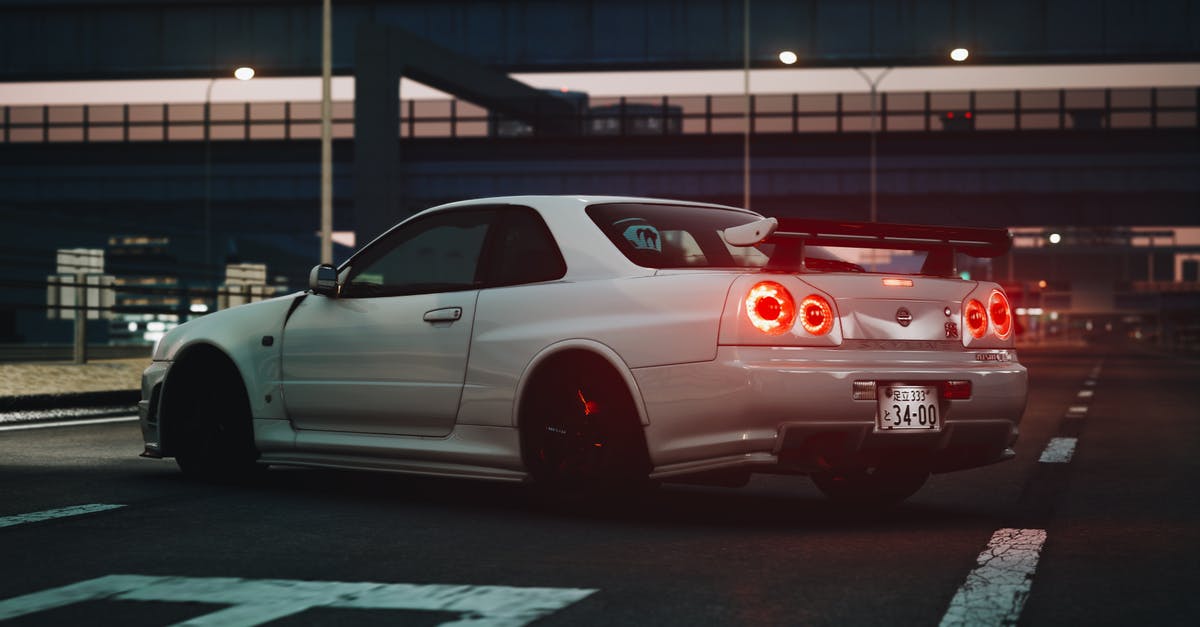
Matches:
[0,350,1200,626]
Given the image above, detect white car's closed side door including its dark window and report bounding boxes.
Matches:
[282,210,497,436]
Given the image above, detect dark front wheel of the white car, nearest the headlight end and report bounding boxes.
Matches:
[173,357,264,483]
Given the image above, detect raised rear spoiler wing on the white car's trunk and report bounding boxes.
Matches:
[725,217,1013,275]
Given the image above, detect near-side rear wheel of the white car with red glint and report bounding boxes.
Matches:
[521,357,650,490]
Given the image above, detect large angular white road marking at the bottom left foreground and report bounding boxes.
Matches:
[0,574,595,627]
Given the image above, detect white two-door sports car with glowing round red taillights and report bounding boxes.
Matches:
[139,196,1026,502]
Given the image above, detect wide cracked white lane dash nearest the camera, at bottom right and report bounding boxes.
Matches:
[940,529,1046,627]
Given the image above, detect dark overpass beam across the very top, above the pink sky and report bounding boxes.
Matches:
[0,0,1200,82]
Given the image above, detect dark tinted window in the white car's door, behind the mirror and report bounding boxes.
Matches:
[341,211,496,298]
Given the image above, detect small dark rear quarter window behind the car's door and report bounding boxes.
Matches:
[487,208,566,287]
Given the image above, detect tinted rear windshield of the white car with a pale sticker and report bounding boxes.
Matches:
[588,203,768,268]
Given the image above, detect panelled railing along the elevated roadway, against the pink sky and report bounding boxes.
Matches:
[0,88,1200,143]
